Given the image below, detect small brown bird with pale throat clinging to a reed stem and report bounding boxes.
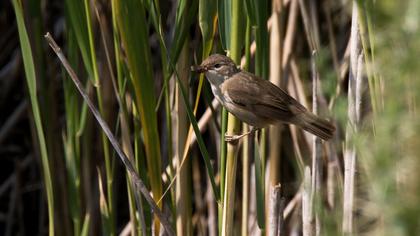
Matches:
[191,54,335,141]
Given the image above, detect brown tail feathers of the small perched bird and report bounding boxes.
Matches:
[293,112,335,140]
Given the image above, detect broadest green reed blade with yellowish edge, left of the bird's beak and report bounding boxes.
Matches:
[113,0,162,231]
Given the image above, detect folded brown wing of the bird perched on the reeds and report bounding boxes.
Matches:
[222,71,306,122]
